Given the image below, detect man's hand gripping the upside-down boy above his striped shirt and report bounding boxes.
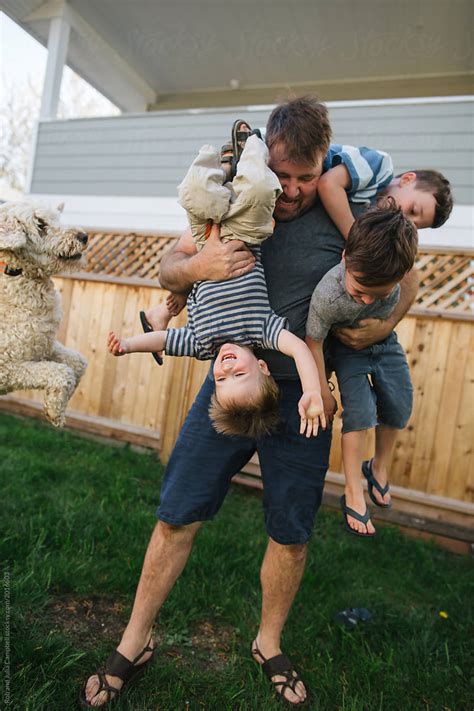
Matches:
[195,225,255,281]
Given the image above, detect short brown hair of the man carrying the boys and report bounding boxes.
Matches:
[266,94,332,163]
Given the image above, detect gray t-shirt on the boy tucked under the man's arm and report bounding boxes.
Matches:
[306,262,400,341]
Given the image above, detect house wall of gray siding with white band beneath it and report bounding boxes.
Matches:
[30,97,474,246]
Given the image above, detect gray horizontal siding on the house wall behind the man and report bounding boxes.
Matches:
[31,101,474,204]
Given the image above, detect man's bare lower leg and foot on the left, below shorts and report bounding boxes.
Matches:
[86,521,201,707]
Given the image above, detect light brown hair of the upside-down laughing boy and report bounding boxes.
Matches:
[209,375,280,439]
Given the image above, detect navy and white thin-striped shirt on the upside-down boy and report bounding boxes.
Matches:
[165,248,287,360]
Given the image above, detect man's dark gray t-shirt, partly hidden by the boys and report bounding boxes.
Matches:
[256,201,366,380]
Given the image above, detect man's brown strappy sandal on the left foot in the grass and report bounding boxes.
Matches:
[79,639,156,709]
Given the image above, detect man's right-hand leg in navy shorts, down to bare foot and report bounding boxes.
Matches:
[252,381,331,705]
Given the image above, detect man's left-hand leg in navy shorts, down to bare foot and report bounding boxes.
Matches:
[85,378,255,706]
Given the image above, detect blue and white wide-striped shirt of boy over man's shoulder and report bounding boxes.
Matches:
[323,143,393,203]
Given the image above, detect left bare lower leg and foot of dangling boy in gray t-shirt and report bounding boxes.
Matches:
[342,430,375,534]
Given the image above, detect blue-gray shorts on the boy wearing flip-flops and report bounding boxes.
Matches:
[329,333,413,434]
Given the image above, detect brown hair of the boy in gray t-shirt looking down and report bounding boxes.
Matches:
[344,197,418,286]
